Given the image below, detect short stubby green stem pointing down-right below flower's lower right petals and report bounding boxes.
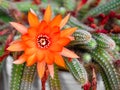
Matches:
[65,59,88,85]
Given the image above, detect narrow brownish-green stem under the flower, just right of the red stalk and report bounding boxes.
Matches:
[49,65,61,90]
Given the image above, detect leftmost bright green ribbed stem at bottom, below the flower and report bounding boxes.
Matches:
[10,64,24,90]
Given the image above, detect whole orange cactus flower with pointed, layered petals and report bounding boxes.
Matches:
[7,6,79,78]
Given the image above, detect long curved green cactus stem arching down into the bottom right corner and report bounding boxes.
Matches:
[91,48,120,90]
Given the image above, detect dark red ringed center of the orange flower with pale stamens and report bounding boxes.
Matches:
[37,35,50,48]
